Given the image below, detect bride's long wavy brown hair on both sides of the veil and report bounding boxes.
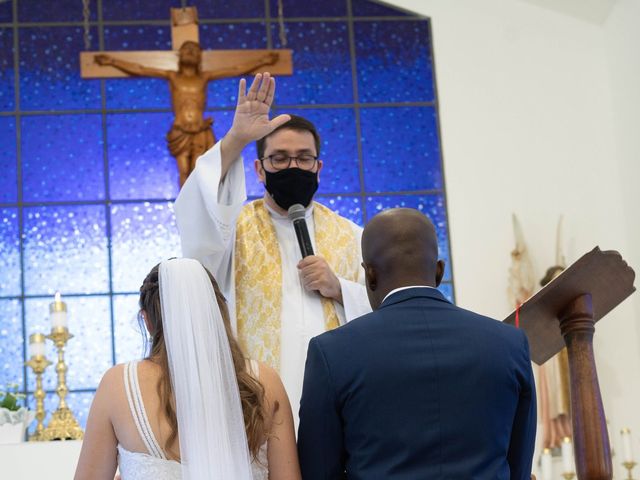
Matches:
[139,265,268,459]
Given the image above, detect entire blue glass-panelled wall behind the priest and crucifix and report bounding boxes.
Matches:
[0,0,454,425]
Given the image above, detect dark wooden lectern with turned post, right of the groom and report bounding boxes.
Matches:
[504,247,635,480]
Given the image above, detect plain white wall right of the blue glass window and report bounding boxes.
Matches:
[389,0,640,472]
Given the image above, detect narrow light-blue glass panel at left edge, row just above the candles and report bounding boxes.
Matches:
[0,208,22,296]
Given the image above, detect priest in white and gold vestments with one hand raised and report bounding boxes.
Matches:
[175,73,370,411]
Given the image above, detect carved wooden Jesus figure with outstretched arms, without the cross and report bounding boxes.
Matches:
[94,41,278,187]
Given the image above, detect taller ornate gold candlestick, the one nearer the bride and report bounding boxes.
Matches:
[42,326,84,440]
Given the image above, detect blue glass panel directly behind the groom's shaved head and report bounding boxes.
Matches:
[367,194,451,281]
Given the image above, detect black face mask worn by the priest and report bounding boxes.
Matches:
[264,168,318,210]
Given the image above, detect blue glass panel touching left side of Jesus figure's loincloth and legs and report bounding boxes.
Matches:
[107,113,178,199]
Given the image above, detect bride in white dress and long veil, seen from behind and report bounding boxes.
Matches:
[75,259,300,480]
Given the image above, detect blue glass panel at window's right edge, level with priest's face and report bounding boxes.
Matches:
[360,107,442,192]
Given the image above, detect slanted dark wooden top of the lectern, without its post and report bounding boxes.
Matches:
[504,247,636,365]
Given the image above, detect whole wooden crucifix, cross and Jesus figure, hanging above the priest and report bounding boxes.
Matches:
[80,7,293,187]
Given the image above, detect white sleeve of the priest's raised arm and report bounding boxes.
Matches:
[175,142,247,294]
